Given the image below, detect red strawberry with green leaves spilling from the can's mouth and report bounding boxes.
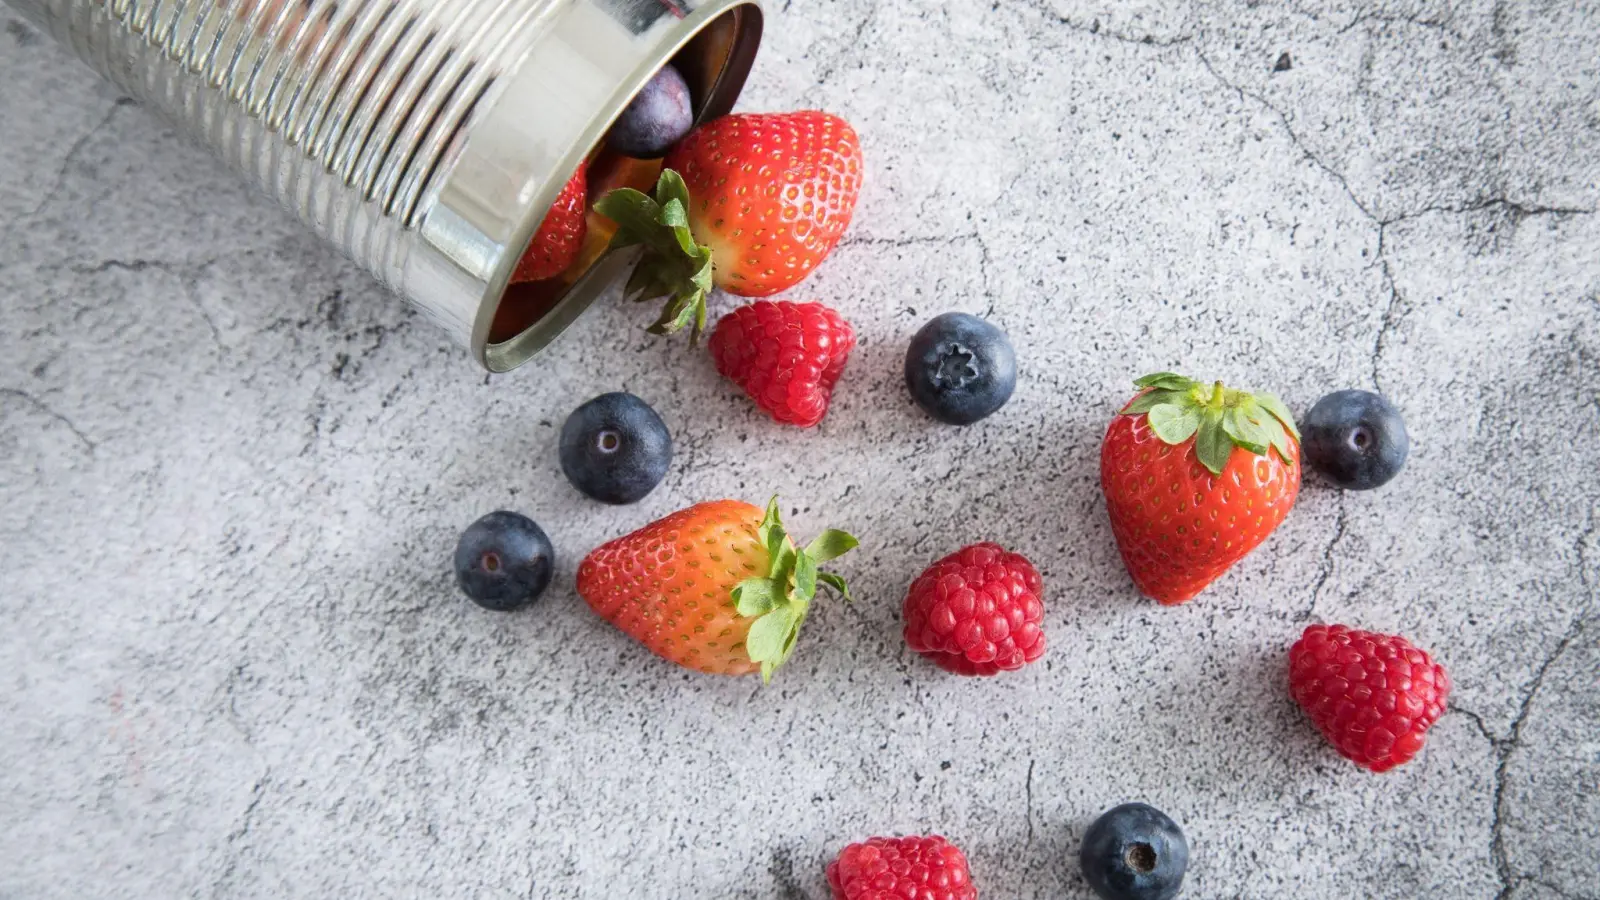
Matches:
[595,110,862,336]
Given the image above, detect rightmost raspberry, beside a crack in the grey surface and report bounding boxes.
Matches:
[1290,625,1450,772]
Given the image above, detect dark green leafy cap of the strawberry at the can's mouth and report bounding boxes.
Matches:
[595,168,712,343]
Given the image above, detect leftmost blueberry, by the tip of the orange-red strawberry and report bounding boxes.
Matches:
[456,509,555,612]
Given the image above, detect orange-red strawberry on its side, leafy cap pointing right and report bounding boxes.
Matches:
[578,498,856,679]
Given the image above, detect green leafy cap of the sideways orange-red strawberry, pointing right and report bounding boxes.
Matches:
[733,496,859,682]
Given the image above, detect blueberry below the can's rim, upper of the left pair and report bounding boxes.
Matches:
[562,392,672,503]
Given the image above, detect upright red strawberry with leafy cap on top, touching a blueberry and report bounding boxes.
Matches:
[1101,373,1301,604]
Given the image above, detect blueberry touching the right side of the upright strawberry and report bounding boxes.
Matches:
[1301,391,1411,490]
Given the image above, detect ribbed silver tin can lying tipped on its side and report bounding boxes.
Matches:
[8,0,762,372]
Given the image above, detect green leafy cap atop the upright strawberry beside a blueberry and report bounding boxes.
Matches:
[1122,372,1299,476]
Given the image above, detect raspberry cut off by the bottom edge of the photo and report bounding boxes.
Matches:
[827,836,978,900]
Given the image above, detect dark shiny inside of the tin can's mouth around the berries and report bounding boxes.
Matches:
[478,3,762,372]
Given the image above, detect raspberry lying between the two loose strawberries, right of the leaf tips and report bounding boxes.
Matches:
[904,543,1045,676]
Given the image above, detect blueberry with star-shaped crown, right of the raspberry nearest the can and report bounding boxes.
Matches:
[906,312,1016,424]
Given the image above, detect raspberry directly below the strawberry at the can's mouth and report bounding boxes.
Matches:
[710,299,856,428]
